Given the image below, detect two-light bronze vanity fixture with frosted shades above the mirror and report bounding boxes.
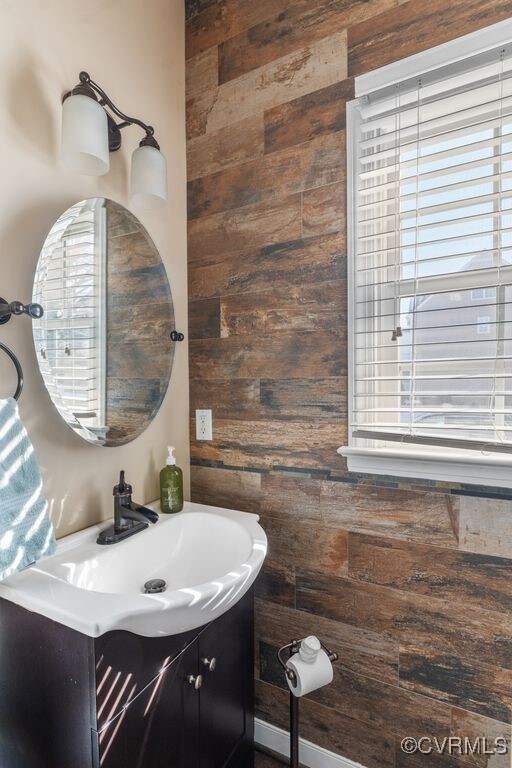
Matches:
[61,72,167,208]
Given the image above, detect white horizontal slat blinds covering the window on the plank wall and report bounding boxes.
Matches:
[350,46,512,451]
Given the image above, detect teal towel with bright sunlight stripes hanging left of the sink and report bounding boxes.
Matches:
[0,397,55,581]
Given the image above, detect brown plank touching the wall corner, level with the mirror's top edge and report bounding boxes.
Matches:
[188,195,302,263]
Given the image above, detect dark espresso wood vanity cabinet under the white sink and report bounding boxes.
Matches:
[0,591,254,768]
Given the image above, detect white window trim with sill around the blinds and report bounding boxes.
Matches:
[338,19,512,488]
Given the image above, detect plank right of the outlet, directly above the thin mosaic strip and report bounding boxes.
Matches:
[190,416,346,470]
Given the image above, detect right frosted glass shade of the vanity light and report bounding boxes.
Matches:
[130,146,167,208]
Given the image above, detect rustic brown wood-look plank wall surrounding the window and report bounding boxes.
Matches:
[187,0,512,768]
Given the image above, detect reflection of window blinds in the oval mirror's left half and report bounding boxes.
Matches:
[34,200,106,431]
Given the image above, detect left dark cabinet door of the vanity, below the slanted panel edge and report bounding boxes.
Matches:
[95,643,199,768]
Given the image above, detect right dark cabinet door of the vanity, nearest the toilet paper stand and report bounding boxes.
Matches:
[199,592,254,768]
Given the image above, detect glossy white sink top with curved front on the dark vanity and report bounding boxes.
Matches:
[0,502,267,637]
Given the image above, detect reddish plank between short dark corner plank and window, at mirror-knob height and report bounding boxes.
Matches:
[220,280,347,338]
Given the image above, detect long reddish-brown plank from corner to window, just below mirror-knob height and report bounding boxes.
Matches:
[190,331,346,380]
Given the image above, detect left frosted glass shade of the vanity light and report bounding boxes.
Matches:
[61,94,110,176]
